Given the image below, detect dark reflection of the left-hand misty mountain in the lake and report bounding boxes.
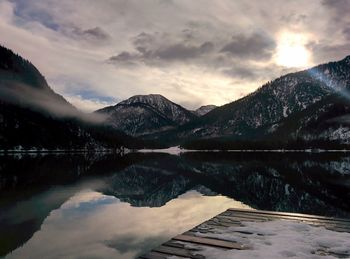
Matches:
[0,154,133,257]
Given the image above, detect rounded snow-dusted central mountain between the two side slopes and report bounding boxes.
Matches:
[95,94,197,136]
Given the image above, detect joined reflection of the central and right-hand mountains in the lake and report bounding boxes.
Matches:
[103,154,350,216]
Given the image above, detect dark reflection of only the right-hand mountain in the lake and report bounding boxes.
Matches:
[183,154,350,216]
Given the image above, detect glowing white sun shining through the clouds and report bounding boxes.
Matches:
[275,33,310,68]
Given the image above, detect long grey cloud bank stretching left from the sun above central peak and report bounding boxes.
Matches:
[108,28,275,81]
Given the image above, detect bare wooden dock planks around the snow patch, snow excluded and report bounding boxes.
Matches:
[139,209,350,259]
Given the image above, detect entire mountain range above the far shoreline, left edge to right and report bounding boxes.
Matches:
[0,44,350,149]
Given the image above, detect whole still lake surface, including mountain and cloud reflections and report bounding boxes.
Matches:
[0,152,350,258]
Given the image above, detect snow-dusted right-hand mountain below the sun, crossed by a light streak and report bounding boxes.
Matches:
[154,56,350,147]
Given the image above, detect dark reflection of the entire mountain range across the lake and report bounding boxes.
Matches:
[0,153,350,256]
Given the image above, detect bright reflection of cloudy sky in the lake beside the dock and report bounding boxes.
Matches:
[9,190,248,258]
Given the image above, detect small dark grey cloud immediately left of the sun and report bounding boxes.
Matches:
[221,33,276,60]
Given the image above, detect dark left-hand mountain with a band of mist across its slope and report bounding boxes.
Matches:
[0,46,137,150]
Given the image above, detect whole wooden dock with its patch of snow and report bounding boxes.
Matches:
[139,209,350,259]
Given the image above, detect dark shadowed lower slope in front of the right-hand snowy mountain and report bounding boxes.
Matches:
[265,94,350,145]
